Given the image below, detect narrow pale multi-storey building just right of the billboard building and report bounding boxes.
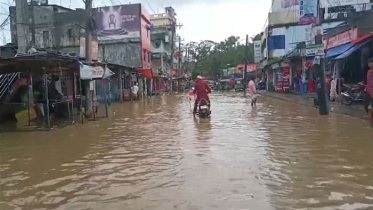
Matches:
[150,7,177,77]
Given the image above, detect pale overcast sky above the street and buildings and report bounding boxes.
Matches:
[0,0,271,44]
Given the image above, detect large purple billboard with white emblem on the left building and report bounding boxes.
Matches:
[95,4,141,41]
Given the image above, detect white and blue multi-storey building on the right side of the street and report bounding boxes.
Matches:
[260,0,372,90]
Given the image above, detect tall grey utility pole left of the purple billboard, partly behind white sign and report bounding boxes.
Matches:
[82,0,93,117]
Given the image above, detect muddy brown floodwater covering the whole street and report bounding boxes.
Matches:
[0,93,373,210]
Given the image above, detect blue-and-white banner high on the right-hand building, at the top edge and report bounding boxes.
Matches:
[299,0,318,25]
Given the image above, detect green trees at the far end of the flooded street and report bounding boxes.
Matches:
[185,36,254,78]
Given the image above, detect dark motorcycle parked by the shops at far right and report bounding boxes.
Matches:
[341,83,365,106]
